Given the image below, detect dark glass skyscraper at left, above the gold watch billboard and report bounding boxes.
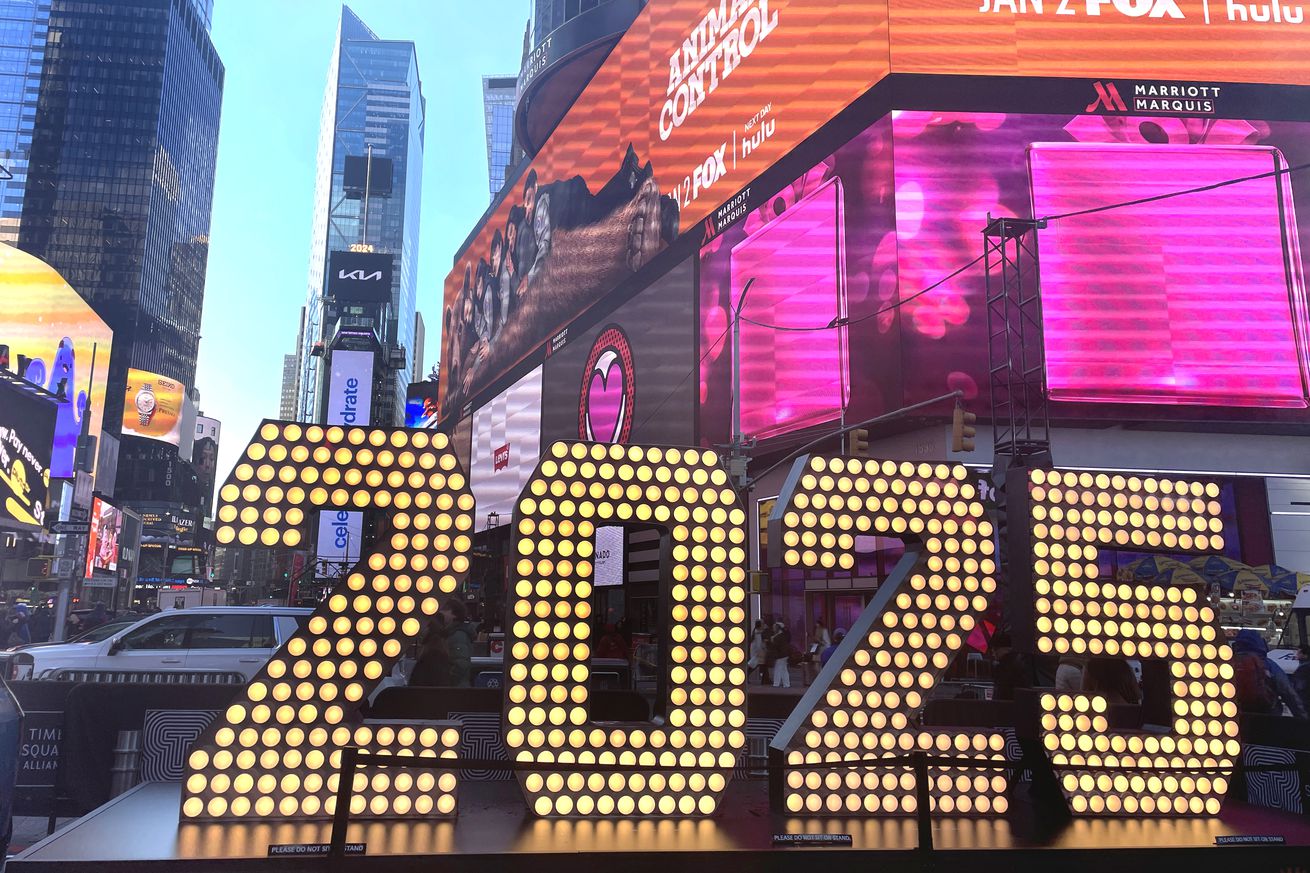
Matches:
[10,0,224,432]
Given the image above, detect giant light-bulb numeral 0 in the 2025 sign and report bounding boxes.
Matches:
[504,440,747,818]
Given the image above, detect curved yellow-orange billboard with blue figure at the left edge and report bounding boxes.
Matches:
[0,245,114,478]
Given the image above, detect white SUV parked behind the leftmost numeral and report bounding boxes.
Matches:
[13,607,313,679]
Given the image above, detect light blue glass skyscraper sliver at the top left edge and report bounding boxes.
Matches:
[0,0,50,245]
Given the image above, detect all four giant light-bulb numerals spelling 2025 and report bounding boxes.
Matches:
[182,421,1239,821]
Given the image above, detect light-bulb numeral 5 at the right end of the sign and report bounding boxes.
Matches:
[1028,469,1241,817]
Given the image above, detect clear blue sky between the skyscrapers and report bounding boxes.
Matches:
[197,0,529,482]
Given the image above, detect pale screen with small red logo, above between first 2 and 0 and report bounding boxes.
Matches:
[469,367,541,531]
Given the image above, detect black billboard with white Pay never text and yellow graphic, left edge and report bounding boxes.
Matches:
[0,374,59,527]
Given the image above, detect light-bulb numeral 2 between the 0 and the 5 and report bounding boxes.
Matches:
[770,456,1009,815]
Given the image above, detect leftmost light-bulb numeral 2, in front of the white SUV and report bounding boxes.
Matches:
[182,422,473,821]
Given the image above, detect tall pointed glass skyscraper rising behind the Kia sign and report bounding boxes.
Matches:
[296,7,424,425]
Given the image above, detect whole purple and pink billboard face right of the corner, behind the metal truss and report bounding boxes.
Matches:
[885,106,1310,419]
